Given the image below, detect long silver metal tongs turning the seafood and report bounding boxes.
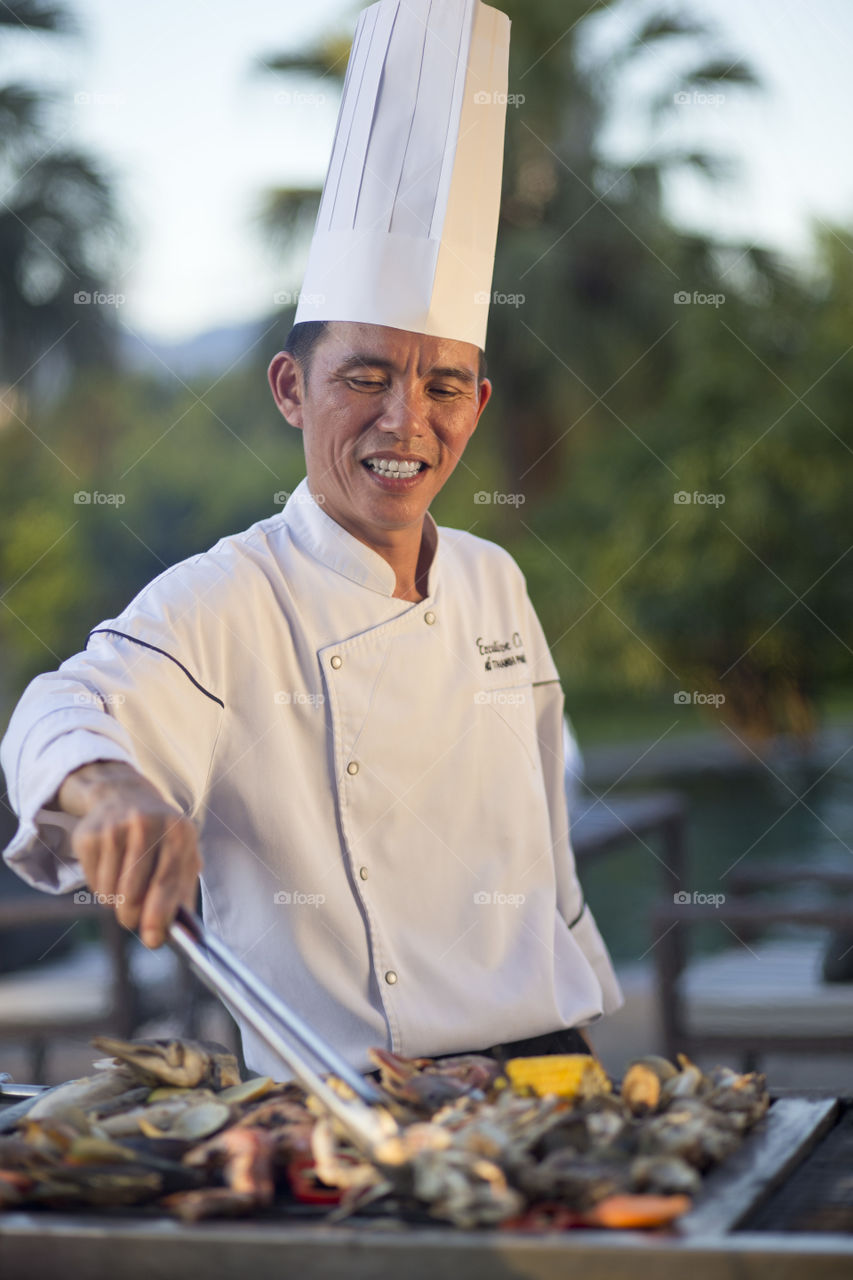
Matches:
[169,906,396,1156]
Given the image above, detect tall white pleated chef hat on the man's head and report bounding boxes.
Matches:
[296,0,510,347]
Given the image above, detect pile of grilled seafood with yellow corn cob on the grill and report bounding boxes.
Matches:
[0,1037,768,1229]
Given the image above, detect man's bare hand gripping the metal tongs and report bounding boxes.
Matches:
[55,760,201,947]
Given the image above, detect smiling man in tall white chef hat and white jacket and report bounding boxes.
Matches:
[1,0,621,1075]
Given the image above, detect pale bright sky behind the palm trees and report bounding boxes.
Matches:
[0,0,853,340]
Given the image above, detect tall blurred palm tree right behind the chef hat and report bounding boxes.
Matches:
[253,0,758,495]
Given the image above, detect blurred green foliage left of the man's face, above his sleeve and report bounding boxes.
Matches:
[0,350,304,696]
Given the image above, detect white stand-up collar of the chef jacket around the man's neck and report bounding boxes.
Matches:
[283,477,439,604]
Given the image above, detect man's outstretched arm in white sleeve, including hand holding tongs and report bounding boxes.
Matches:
[0,623,224,946]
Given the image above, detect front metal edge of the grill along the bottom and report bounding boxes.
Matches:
[0,1213,853,1280]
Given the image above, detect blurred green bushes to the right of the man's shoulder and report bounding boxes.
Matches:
[432,221,853,739]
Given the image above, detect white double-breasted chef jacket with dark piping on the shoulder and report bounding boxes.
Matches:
[0,480,621,1078]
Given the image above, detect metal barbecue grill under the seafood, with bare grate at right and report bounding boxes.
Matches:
[0,1097,853,1280]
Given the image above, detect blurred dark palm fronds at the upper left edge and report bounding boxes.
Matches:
[0,0,118,394]
